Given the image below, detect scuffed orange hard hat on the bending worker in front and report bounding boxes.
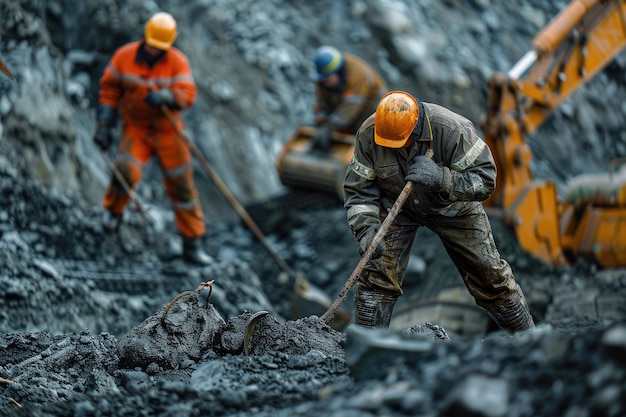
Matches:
[374,91,419,148]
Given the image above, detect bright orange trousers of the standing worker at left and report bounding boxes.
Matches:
[102,128,205,238]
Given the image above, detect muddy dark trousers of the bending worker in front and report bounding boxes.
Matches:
[355,204,534,331]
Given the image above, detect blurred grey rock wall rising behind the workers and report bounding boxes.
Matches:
[0,0,626,221]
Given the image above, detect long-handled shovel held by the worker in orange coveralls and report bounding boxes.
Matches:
[160,104,349,329]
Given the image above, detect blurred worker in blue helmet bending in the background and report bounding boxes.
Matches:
[313,45,387,149]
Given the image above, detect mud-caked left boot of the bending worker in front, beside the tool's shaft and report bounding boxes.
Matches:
[354,288,397,328]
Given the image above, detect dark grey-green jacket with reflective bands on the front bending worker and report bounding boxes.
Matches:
[343,103,496,240]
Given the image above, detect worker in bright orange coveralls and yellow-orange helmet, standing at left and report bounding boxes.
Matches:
[94,12,211,264]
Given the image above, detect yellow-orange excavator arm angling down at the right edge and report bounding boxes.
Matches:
[482,0,626,265]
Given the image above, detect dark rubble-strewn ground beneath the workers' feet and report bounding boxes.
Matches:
[0,170,626,417]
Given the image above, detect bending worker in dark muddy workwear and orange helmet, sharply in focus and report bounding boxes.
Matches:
[344,91,534,331]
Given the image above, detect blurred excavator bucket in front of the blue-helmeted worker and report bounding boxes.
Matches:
[276,126,355,198]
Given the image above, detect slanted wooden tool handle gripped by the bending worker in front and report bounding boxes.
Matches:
[320,149,433,324]
